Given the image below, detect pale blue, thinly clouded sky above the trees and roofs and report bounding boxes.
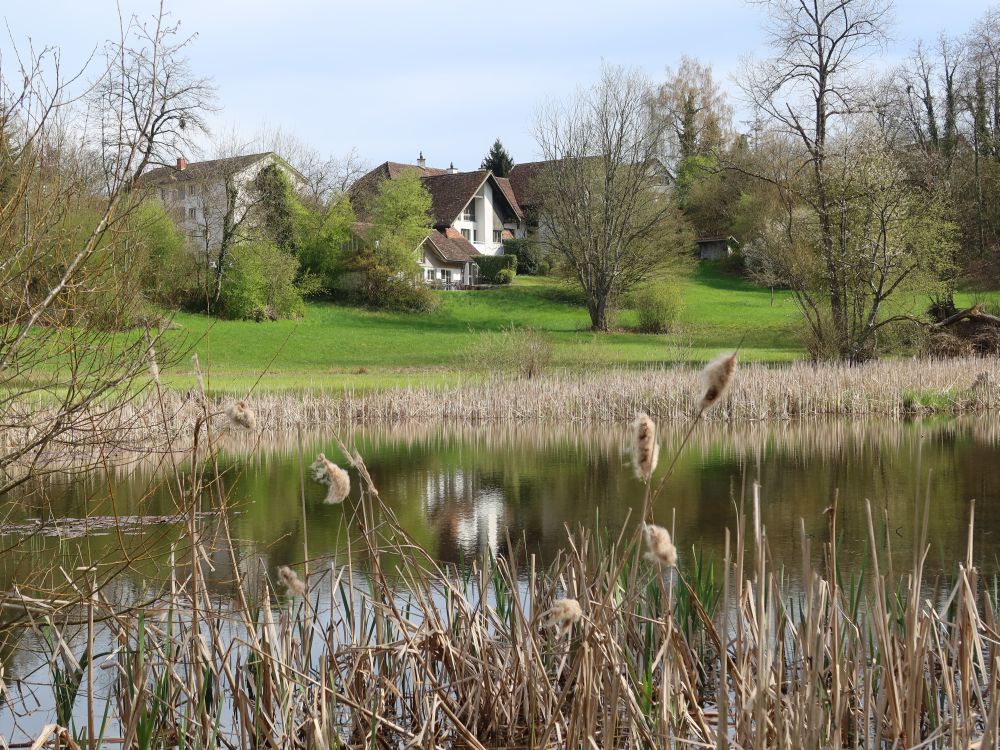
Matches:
[0,0,990,169]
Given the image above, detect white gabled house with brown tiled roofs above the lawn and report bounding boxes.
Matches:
[350,154,527,288]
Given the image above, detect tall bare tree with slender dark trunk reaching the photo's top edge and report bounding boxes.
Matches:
[743,0,890,357]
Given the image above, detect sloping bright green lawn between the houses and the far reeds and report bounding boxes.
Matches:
[164,263,804,390]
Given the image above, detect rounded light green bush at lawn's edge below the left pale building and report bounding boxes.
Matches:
[221,242,305,320]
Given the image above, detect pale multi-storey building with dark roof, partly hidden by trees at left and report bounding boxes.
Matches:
[140,151,303,250]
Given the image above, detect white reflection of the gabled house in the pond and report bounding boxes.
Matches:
[423,469,506,560]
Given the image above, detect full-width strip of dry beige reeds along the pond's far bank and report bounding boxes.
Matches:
[0,358,1000,479]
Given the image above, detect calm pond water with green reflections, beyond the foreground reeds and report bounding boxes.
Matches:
[0,418,1000,593]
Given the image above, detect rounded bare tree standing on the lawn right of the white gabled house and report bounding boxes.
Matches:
[535,67,693,331]
